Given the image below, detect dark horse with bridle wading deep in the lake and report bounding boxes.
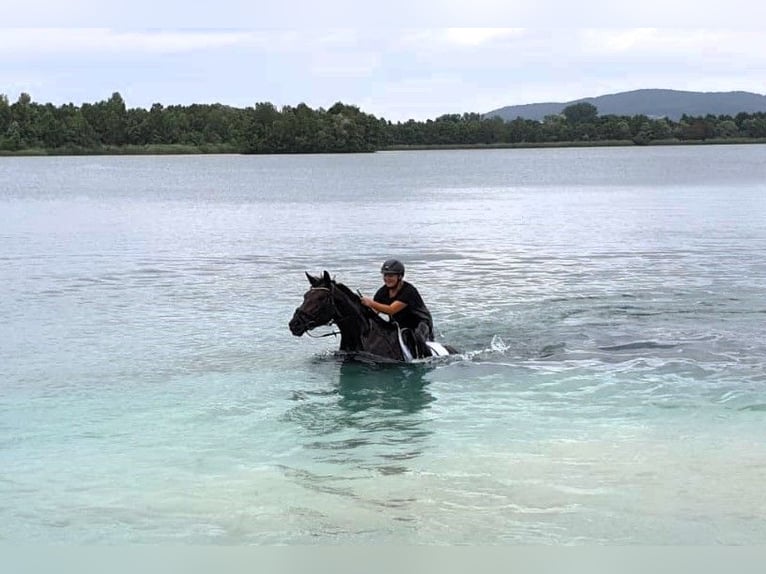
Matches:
[289,271,458,363]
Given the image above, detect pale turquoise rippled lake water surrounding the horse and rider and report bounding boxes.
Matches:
[0,145,766,545]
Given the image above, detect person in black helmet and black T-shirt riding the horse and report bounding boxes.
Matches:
[362,259,434,357]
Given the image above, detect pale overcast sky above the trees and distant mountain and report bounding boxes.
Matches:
[0,0,766,121]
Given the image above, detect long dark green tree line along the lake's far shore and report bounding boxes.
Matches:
[0,92,766,154]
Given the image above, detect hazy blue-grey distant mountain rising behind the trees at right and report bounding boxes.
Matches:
[484,90,766,121]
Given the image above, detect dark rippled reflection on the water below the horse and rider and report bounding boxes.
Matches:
[285,356,434,478]
